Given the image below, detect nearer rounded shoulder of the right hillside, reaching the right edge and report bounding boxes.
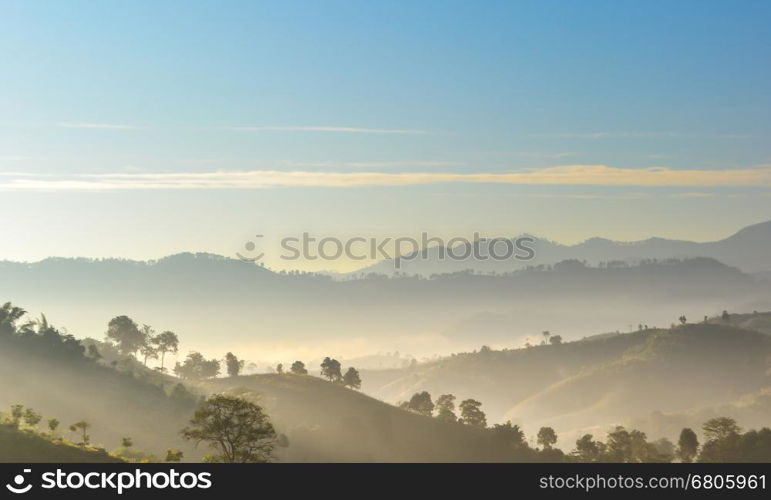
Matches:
[508,325,771,427]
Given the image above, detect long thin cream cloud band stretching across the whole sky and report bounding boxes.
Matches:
[0,165,771,191]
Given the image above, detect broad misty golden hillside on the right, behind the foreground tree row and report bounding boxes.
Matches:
[362,324,771,436]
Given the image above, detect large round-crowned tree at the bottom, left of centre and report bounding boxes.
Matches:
[182,394,276,463]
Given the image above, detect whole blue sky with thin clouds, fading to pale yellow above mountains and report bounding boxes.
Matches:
[0,1,771,270]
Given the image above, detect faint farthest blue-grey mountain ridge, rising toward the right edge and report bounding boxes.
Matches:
[359,220,771,276]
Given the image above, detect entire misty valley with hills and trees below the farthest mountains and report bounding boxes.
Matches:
[0,223,771,462]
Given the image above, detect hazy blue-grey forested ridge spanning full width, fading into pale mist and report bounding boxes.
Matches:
[0,254,771,356]
